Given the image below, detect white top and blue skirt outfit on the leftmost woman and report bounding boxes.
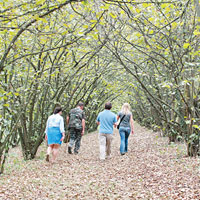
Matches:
[45,114,65,145]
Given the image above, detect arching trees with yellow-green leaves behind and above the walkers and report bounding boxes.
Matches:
[0,0,200,171]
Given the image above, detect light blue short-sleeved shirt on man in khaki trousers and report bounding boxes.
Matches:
[97,110,117,134]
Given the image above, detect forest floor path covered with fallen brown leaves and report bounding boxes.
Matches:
[0,124,200,200]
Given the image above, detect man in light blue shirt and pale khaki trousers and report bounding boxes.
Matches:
[97,102,117,160]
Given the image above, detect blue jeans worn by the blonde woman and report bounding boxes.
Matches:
[119,127,131,154]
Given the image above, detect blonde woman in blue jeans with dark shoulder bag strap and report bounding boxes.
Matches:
[117,103,134,155]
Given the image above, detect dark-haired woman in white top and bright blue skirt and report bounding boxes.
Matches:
[45,107,65,163]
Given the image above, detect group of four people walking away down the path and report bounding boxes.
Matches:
[45,102,134,163]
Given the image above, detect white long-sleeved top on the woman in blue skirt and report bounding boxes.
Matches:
[45,113,65,133]
